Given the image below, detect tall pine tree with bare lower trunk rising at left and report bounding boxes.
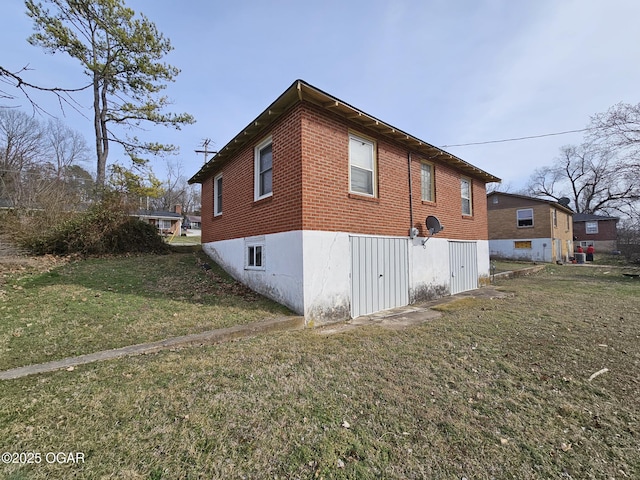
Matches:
[25,0,195,187]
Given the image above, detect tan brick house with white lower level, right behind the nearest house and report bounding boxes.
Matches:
[487,192,573,262]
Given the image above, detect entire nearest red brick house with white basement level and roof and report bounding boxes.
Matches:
[189,80,499,323]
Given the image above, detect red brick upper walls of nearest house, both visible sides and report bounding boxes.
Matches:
[202,103,488,242]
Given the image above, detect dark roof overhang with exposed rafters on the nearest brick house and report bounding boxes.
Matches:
[189,80,501,183]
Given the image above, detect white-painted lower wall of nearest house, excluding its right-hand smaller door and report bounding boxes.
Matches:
[203,231,489,324]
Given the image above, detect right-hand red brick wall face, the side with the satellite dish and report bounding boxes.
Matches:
[302,106,487,240]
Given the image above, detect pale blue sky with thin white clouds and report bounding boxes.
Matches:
[0,0,640,192]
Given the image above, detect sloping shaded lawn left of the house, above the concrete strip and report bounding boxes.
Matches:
[0,253,291,370]
